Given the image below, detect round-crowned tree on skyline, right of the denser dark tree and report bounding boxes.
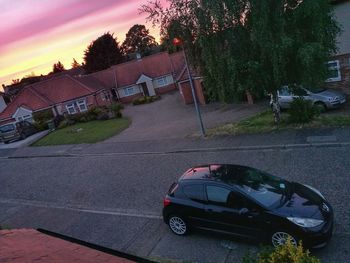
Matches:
[122,24,158,56]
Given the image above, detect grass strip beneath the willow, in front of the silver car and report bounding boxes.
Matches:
[207,110,350,137]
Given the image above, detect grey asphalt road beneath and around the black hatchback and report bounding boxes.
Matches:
[0,146,350,262]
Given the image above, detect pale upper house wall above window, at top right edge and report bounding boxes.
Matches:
[334,1,350,55]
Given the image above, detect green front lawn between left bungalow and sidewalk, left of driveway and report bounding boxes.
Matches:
[32,118,130,146]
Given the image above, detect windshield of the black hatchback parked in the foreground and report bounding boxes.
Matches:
[224,167,292,208]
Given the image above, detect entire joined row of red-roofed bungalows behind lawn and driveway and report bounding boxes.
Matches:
[0,52,205,125]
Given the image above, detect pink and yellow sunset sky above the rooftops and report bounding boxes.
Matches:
[0,0,164,90]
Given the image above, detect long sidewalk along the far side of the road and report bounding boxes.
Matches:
[0,128,350,158]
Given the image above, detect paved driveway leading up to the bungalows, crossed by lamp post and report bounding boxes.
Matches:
[106,92,266,142]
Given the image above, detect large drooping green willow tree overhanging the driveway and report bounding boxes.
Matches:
[141,0,340,102]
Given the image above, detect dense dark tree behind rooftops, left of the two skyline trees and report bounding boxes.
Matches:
[84,32,123,73]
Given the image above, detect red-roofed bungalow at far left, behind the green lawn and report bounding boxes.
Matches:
[0,75,112,125]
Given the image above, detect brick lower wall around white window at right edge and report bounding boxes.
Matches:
[326,54,350,95]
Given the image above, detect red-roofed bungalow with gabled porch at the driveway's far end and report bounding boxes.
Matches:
[91,52,205,104]
